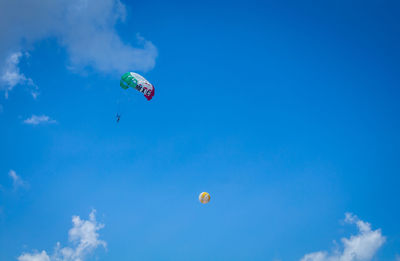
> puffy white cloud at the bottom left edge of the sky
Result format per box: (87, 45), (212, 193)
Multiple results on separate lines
(18, 210), (107, 261)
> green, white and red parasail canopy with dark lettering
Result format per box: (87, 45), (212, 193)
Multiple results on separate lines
(119, 72), (154, 101)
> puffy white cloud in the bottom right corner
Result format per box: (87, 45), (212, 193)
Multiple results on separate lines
(301, 213), (386, 261)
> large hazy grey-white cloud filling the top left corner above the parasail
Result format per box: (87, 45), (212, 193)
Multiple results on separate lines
(0, 0), (157, 96)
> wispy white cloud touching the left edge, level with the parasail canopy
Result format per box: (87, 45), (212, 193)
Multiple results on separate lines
(0, 52), (39, 99)
